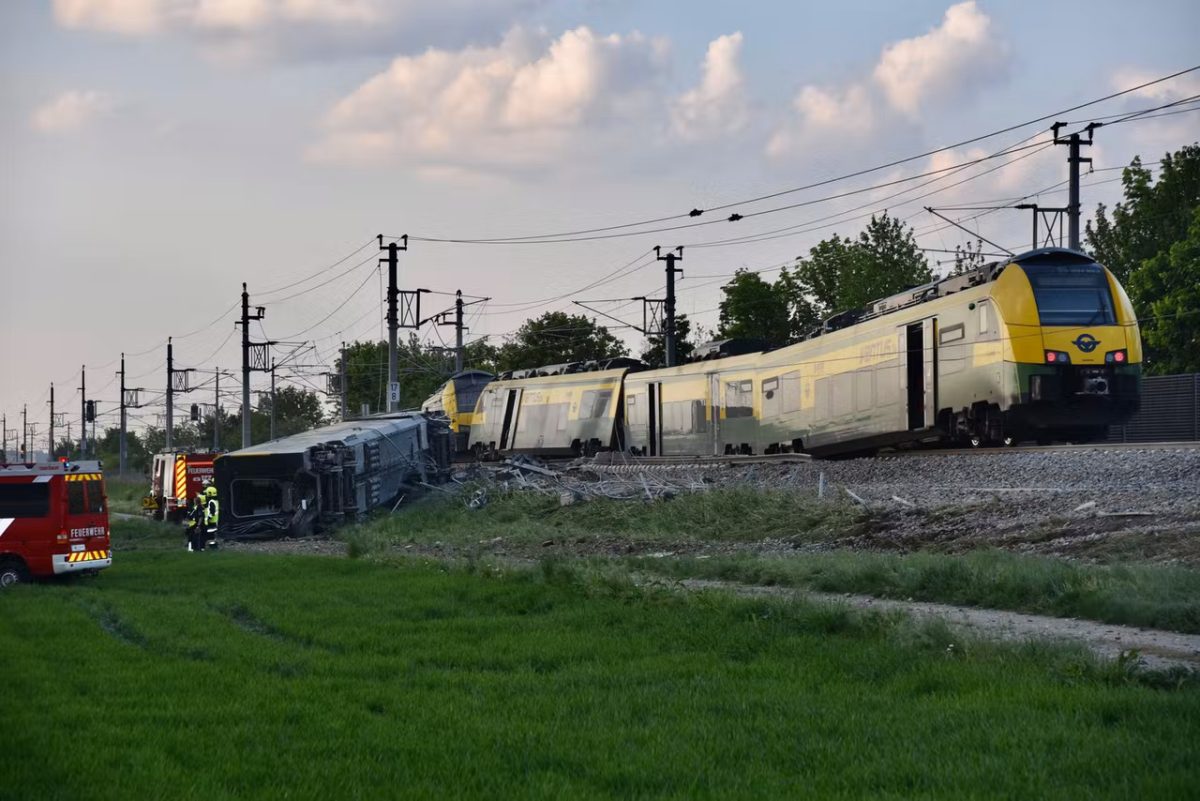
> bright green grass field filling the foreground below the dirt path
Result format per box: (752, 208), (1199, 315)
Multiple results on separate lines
(0, 546), (1200, 800)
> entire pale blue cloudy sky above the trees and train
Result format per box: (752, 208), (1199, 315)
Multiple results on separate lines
(0, 0), (1200, 439)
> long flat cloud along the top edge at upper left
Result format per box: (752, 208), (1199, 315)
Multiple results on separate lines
(54, 0), (545, 60)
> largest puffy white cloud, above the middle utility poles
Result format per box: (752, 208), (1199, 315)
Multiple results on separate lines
(308, 28), (667, 167)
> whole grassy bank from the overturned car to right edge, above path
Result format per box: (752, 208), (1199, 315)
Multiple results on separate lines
(338, 489), (1200, 633)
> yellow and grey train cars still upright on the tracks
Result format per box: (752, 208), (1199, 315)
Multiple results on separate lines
(444, 248), (1141, 456)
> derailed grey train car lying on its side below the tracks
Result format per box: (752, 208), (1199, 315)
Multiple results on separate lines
(215, 412), (452, 538)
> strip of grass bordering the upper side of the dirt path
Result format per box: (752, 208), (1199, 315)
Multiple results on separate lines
(632, 550), (1200, 633)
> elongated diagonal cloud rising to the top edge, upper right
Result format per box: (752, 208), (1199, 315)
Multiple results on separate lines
(767, 0), (1008, 158)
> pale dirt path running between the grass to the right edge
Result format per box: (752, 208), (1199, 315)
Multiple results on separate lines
(679, 579), (1200, 670)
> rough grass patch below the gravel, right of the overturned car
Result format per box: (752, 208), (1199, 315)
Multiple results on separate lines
(340, 488), (866, 549)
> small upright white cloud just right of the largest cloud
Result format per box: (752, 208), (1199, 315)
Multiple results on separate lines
(672, 32), (750, 139)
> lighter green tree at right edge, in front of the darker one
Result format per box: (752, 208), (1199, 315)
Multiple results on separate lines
(1129, 206), (1200, 373)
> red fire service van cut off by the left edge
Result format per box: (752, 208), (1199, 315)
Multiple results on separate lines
(0, 462), (113, 586)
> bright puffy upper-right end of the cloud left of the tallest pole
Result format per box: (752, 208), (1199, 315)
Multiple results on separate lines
(874, 0), (1006, 116)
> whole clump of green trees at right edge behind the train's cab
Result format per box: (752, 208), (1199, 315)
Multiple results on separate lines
(1087, 144), (1200, 373)
